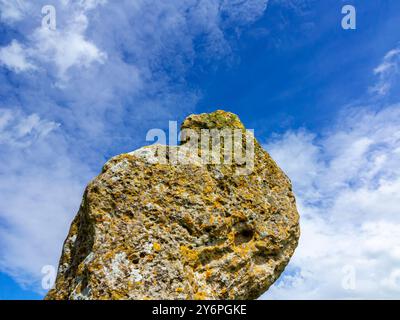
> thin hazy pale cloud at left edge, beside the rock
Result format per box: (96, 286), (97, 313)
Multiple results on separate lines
(0, 108), (90, 290)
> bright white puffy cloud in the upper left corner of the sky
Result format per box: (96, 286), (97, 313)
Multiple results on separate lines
(0, 1), (107, 81)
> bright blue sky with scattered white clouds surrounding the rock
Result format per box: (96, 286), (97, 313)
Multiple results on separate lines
(0, 0), (400, 299)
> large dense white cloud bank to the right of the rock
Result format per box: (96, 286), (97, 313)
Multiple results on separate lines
(264, 105), (400, 299)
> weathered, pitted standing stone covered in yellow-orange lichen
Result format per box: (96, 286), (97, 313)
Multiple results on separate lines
(46, 111), (300, 299)
